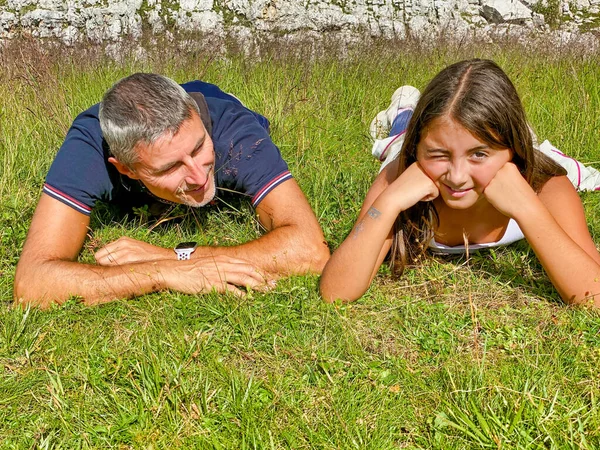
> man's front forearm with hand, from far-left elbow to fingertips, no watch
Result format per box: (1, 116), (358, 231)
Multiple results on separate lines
(15, 255), (267, 307)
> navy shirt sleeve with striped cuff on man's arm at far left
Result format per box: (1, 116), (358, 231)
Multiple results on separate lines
(43, 105), (113, 215)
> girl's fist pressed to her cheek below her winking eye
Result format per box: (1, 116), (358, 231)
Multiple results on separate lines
(382, 162), (440, 211)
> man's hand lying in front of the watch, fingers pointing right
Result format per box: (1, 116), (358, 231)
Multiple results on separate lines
(163, 255), (275, 296)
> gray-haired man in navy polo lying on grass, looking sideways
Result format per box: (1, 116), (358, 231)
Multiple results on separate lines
(14, 74), (329, 307)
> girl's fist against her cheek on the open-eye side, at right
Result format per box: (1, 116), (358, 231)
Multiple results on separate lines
(483, 162), (537, 219)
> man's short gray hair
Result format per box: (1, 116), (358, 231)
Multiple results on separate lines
(99, 73), (199, 168)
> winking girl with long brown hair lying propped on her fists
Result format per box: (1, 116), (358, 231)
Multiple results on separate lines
(320, 59), (600, 306)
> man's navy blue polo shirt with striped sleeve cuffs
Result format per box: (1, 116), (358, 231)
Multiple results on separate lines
(43, 81), (292, 215)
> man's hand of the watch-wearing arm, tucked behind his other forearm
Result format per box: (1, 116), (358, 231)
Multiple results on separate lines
(94, 236), (177, 266)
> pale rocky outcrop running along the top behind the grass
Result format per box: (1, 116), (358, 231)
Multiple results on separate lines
(0, 0), (600, 42)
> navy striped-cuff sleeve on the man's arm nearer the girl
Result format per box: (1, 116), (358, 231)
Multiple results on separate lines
(207, 99), (292, 207)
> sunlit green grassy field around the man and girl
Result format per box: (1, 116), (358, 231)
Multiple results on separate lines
(0, 34), (600, 449)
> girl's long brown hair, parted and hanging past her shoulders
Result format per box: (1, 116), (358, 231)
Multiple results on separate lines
(391, 59), (566, 274)
